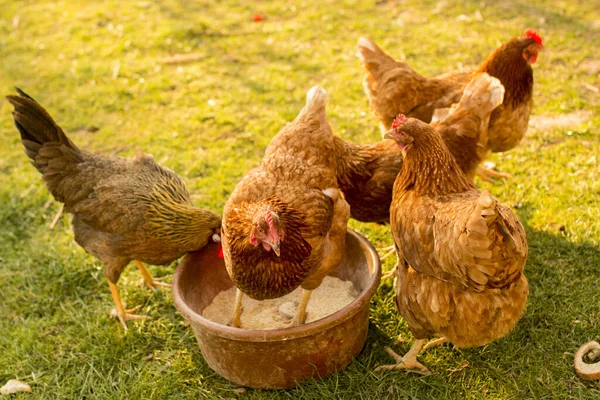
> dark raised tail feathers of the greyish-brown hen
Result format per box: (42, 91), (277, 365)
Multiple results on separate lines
(6, 88), (77, 160)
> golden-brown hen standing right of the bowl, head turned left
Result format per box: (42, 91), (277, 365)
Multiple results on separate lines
(379, 116), (528, 370)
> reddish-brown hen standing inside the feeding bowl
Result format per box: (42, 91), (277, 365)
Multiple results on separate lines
(222, 87), (350, 327)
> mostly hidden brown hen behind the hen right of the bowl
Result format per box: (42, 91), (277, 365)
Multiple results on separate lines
(334, 73), (504, 223)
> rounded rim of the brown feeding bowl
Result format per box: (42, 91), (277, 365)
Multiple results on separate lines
(172, 228), (381, 342)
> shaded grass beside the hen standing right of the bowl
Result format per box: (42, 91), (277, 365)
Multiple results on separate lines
(358, 204), (600, 398)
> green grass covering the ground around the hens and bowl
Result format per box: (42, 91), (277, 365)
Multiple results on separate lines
(0, 0), (600, 399)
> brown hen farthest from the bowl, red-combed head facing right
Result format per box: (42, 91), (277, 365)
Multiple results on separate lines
(358, 30), (544, 179)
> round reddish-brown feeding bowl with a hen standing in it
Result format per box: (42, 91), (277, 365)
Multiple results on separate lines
(173, 229), (381, 389)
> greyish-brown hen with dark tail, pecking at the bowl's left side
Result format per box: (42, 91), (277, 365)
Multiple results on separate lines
(7, 89), (221, 329)
